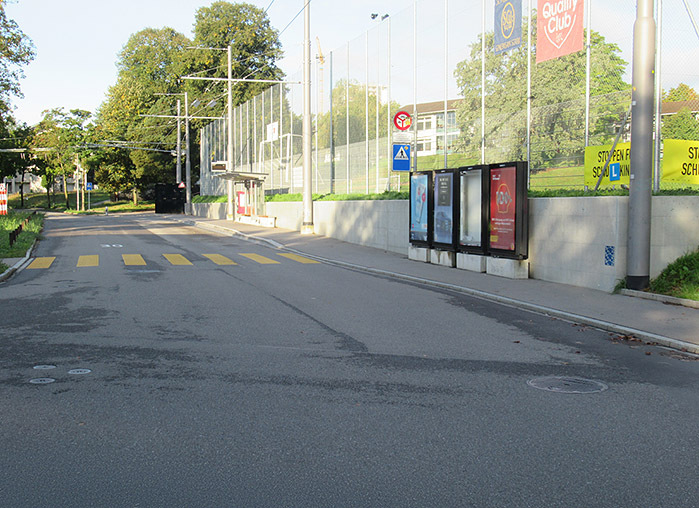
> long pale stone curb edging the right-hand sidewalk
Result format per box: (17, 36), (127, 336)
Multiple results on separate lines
(175, 219), (699, 354)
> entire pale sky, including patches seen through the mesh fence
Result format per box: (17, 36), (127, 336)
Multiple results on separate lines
(5, 0), (699, 125)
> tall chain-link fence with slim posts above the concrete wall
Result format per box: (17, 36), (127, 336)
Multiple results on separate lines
(201, 0), (699, 194)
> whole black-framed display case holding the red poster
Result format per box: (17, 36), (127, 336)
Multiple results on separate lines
(485, 162), (529, 260)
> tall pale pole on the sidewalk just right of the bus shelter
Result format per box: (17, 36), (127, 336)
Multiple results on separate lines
(301, 0), (314, 235)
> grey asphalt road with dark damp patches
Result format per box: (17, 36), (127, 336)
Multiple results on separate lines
(0, 214), (699, 507)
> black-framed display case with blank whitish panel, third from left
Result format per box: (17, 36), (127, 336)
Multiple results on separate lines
(457, 165), (490, 255)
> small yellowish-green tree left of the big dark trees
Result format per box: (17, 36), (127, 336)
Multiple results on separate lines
(32, 108), (92, 208)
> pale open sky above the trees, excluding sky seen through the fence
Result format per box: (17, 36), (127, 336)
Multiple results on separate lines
(5, 0), (413, 125)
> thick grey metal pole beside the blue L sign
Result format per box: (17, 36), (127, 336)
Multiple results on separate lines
(626, 0), (659, 290)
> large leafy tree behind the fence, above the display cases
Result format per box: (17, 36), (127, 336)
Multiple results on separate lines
(454, 19), (630, 169)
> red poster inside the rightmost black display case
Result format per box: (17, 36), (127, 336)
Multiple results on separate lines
(490, 167), (517, 251)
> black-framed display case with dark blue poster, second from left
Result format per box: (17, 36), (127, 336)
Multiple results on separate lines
(432, 169), (459, 250)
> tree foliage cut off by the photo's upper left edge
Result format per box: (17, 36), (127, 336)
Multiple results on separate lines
(0, 2), (35, 121)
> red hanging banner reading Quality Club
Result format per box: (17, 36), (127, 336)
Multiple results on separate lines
(536, 0), (585, 63)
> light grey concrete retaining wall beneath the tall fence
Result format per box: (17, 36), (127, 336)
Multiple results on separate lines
(195, 196), (699, 291)
